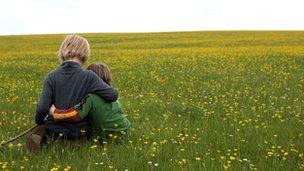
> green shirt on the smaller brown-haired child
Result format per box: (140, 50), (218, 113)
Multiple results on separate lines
(78, 94), (131, 133)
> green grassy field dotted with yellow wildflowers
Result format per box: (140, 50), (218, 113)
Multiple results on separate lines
(0, 32), (304, 170)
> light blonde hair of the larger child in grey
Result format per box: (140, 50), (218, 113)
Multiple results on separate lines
(58, 35), (91, 63)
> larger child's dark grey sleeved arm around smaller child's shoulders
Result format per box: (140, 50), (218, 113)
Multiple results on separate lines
(89, 71), (118, 102)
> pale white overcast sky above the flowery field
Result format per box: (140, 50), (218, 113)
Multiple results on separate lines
(0, 0), (304, 35)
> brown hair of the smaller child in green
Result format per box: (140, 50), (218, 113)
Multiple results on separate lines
(87, 63), (112, 85)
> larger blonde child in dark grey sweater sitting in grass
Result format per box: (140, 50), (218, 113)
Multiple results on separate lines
(26, 35), (118, 152)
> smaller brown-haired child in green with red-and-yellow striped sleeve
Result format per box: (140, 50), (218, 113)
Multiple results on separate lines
(50, 63), (131, 142)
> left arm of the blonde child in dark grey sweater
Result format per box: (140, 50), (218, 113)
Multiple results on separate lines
(35, 75), (52, 124)
